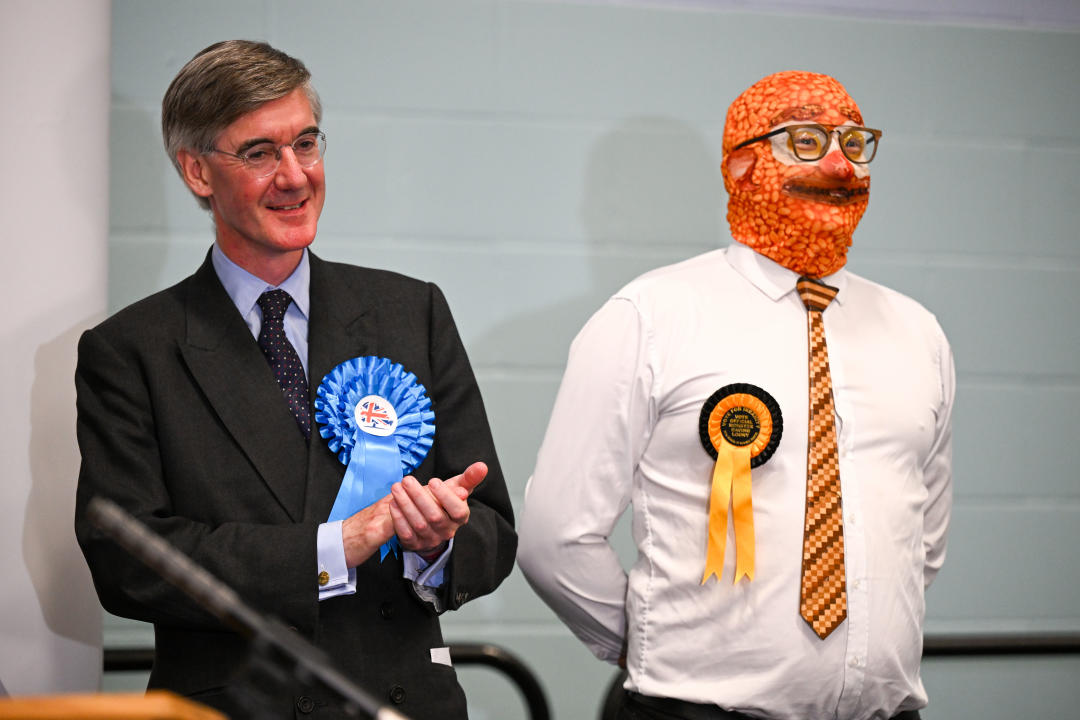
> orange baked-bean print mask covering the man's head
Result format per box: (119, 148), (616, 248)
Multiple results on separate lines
(721, 71), (870, 277)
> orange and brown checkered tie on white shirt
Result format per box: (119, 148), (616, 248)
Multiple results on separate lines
(796, 277), (848, 639)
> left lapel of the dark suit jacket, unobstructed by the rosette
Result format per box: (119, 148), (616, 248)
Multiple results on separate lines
(180, 254), (318, 520)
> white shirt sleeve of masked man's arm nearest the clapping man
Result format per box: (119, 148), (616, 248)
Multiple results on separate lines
(517, 298), (653, 662)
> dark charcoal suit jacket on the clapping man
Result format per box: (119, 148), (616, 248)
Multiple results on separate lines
(76, 250), (516, 720)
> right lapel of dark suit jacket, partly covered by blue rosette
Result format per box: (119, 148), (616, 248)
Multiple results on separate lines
(303, 252), (378, 522)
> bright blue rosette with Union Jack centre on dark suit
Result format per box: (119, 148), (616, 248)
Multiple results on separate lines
(315, 355), (435, 559)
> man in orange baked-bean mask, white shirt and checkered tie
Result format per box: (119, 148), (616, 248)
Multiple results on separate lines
(518, 72), (955, 720)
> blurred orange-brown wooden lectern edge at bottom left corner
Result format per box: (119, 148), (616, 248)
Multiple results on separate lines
(0, 690), (227, 720)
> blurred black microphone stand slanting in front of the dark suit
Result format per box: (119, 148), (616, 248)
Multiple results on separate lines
(87, 498), (408, 720)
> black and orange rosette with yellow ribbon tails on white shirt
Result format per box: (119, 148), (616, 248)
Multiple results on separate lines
(699, 382), (784, 585)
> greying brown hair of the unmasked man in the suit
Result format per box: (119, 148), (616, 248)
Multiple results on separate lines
(161, 40), (323, 209)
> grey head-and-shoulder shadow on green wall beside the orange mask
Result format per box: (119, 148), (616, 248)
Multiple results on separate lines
(470, 117), (726, 375)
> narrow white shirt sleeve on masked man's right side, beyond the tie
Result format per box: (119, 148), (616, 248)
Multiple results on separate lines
(922, 328), (956, 587)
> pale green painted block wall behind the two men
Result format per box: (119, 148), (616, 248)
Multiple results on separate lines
(107, 0), (1080, 720)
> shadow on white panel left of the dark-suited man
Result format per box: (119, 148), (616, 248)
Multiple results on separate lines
(23, 313), (102, 649)
